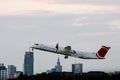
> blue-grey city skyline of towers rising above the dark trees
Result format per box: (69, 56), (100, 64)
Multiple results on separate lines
(0, 57), (83, 74)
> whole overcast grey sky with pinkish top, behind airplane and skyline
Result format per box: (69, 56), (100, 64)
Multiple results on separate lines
(0, 0), (120, 73)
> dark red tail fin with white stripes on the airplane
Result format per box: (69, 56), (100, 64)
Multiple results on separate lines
(96, 46), (111, 59)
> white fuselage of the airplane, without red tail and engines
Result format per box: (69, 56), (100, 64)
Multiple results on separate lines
(31, 44), (99, 59)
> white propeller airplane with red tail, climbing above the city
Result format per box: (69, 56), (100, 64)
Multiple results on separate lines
(30, 43), (111, 59)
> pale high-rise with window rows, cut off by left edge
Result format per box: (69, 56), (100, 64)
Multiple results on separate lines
(0, 63), (7, 80)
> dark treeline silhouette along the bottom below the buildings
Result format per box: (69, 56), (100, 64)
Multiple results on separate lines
(8, 72), (120, 80)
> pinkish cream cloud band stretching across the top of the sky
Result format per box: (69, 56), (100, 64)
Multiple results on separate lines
(0, 0), (120, 15)
